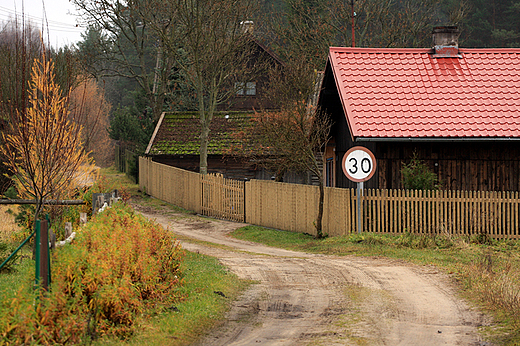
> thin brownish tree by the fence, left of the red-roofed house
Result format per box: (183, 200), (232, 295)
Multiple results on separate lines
(229, 57), (331, 238)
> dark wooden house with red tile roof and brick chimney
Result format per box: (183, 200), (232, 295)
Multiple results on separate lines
(319, 27), (520, 191)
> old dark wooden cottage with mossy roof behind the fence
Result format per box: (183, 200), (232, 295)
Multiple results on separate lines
(145, 29), (283, 180)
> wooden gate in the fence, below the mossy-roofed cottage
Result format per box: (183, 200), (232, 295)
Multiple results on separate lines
(201, 174), (245, 222)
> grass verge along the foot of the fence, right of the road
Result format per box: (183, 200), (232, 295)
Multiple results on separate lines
(232, 226), (520, 345)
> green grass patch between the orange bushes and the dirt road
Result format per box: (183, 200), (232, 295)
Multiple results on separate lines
(94, 252), (250, 346)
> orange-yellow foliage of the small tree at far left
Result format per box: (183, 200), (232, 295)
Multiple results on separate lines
(0, 58), (92, 203)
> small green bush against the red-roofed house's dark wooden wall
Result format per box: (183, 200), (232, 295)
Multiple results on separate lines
(401, 153), (440, 190)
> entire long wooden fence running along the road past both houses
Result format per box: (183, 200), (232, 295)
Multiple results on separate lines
(139, 158), (520, 239)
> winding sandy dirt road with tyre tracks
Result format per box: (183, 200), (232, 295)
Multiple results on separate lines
(136, 206), (490, 346)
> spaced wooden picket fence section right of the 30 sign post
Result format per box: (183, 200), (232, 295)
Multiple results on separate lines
(362, 190), (520, 238)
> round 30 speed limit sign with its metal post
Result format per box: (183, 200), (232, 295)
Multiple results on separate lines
(342, 147), (376, 233)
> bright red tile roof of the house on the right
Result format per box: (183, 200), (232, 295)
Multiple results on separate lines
(329, 48), (520, 139)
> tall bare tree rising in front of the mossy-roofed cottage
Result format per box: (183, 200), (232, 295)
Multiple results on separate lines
(155, 0), (255, 174)
